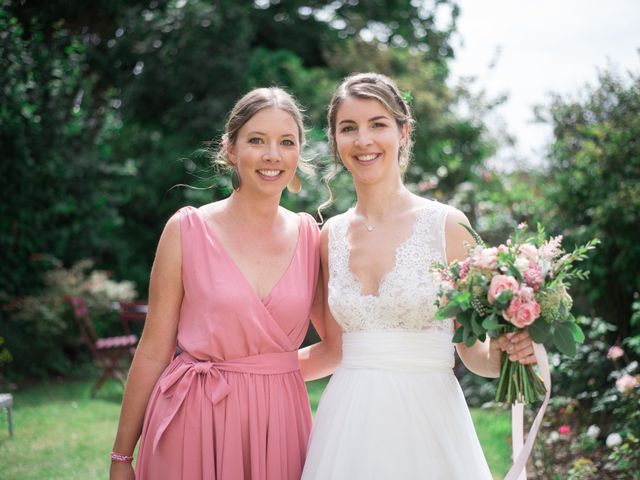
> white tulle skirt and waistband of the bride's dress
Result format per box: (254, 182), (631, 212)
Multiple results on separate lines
(302, 330), (492, 480)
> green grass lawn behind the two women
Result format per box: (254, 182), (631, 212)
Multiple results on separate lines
(0, 380), (510, 480)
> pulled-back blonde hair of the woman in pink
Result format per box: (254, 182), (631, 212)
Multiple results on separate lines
(209, 87), (313, 173)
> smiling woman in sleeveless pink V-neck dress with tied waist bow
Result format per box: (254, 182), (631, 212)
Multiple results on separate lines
(110, 88), (321, 480)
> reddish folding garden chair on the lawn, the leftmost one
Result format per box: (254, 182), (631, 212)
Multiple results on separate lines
(65, 295), (138, 397)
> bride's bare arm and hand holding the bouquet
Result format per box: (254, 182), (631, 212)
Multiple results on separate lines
(445, 209), (536, 378)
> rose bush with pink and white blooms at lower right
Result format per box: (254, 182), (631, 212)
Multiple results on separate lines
(534, 314), (640, 480)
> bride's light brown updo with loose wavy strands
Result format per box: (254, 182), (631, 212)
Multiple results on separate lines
(318, 72), (414, 216)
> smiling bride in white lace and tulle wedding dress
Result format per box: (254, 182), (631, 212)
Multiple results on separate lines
(300, 73), (535, 480)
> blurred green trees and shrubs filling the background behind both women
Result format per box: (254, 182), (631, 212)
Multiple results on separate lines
(0, 0), (640, 478)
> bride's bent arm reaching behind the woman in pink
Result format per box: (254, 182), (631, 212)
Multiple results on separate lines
(298, 221), (342, 381)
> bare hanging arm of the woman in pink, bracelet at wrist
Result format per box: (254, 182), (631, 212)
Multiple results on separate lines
(110, 214), (183, 480)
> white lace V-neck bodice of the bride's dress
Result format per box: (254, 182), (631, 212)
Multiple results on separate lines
(328, 201), (453, 332)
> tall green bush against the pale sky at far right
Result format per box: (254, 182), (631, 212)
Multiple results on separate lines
(547, 67), (640, 337)
